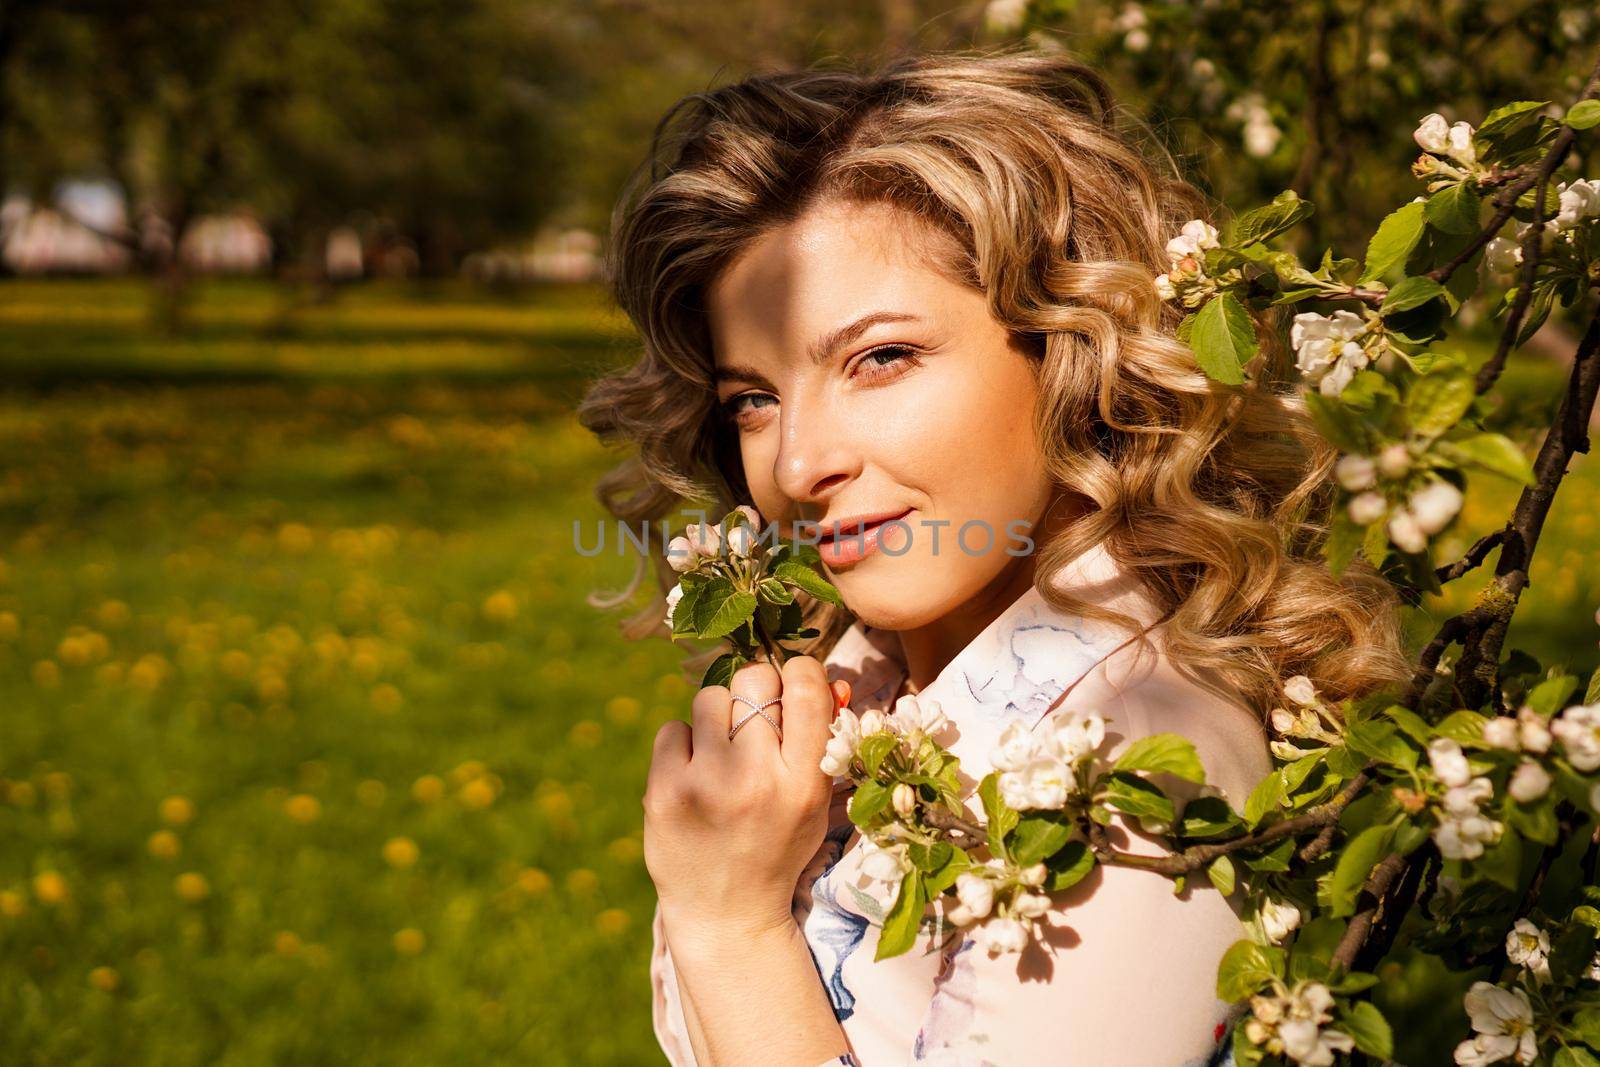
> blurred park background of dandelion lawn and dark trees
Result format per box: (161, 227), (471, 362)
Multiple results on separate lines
(0, 0), (1600, 1065)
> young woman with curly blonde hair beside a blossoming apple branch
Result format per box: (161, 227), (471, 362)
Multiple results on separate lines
(581, 50), (1405, 1067)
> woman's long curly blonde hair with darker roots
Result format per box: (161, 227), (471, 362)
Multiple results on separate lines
(579, 46), (1408, 715)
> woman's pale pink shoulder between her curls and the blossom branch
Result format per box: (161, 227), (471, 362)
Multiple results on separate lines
(1058, 627), (1274, 809)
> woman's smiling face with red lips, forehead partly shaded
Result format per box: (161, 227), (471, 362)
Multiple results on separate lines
(707, 202), (1053, 630)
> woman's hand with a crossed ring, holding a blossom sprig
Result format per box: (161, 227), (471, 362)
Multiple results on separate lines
(645, 656), (850, 949)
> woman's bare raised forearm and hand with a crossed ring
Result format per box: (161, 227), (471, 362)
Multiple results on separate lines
(645, 656), (850, 1067)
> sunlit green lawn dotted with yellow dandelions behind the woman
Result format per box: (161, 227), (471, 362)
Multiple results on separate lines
(0, 280), (1600, 1067)
